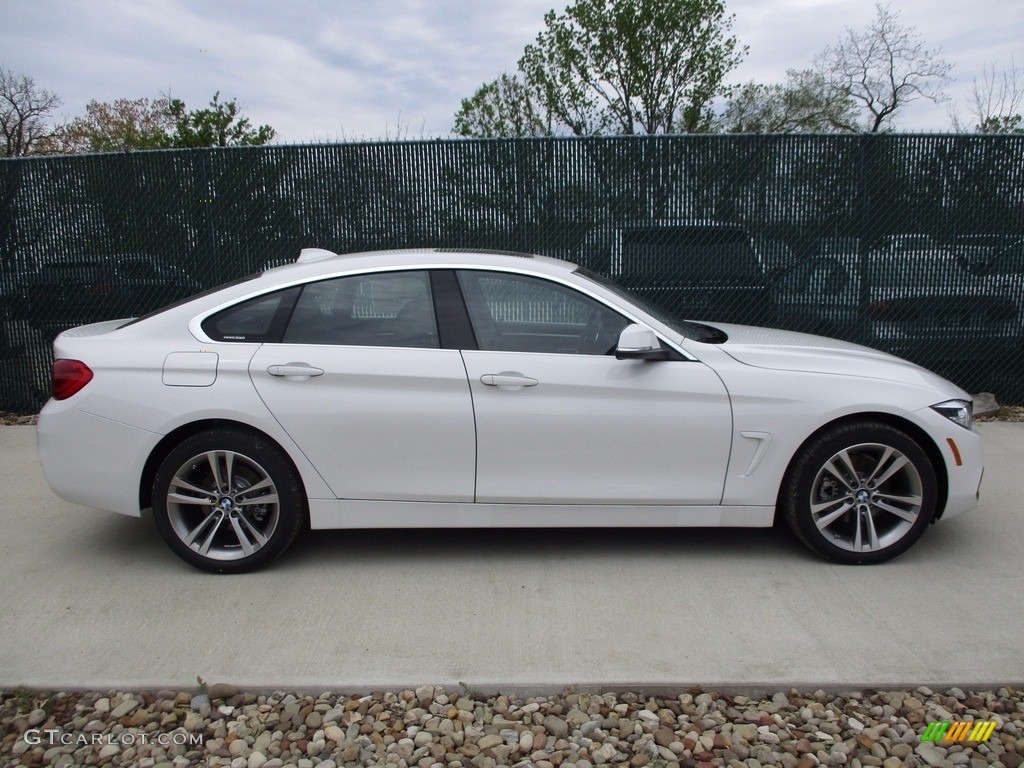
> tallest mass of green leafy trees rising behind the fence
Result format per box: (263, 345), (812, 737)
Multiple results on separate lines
(456, 0), (745, 136)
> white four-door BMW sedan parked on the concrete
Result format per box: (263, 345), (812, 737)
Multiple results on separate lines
(39, 249), (982, 572)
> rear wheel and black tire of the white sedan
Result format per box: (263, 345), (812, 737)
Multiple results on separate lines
(153, 428), (309, 573)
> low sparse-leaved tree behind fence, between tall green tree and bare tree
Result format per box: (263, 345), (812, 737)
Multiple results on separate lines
(715, 70), (858, 133)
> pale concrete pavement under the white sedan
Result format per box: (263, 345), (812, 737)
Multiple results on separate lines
(0, 423), (1024, 692)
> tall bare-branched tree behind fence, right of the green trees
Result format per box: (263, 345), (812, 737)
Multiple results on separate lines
(817, 4), (952, 133)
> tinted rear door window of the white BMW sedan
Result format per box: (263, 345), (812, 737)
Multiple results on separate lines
(285, 271), (438, 348)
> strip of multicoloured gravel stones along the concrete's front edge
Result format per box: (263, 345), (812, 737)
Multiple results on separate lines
(0, 685), (1024, 768)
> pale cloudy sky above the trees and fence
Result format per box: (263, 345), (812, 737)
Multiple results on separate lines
(0, 0), (1024, 143)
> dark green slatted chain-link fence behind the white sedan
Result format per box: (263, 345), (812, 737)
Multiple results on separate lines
(0, 135), (1024, 411)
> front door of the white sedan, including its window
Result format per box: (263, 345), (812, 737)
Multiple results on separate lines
(460, 270), (732, 505)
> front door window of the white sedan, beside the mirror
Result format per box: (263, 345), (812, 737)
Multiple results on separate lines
(459, 271), (629, 354)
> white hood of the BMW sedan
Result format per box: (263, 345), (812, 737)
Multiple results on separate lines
(715, 324), (967, 395)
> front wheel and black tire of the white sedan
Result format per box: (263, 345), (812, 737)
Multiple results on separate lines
(779, 422), (938, 565)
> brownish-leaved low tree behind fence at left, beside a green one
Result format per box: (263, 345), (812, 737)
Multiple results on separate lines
(46, 98), (174, 153)
